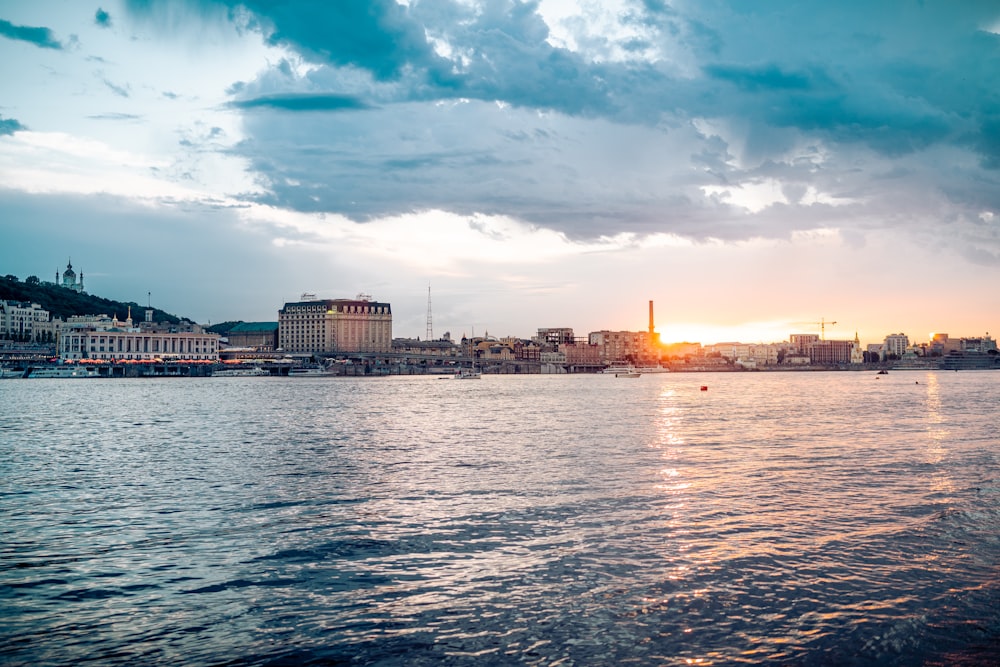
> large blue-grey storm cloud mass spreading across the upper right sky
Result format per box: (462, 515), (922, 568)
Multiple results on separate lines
(133, 0), (1000, 253)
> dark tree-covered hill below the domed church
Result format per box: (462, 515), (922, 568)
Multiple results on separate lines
(0, 275), (181, 324)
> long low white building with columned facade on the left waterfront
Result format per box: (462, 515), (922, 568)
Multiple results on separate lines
(58, 316), (219, 361)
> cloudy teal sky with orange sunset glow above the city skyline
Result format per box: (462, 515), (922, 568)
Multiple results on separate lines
(0, 0), (1000, 344)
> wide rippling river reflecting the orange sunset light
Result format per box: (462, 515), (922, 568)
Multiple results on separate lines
(0, 371), (1000, 666)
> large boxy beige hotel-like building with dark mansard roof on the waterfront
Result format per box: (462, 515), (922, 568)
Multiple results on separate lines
(278, 294), (392, 353)
